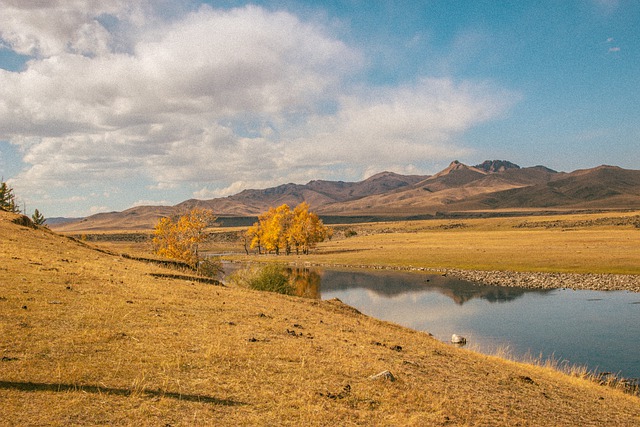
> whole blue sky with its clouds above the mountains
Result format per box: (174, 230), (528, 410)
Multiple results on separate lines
(0, 0), (640, 217)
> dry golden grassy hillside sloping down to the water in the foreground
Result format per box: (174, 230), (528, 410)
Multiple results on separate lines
(0, 213), (640, 426)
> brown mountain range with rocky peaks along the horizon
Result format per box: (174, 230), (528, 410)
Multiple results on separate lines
(49, 160), (640, 232)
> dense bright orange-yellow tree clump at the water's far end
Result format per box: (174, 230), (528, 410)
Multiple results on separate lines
(246, 202), (331, 255)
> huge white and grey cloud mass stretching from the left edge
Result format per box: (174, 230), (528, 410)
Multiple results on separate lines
(0, 0), (517, 211)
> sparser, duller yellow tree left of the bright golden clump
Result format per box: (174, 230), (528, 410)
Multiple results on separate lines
(153, 208), (216, 268)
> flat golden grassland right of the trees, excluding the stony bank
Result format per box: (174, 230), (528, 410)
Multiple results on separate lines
(228, 212), (640, 274)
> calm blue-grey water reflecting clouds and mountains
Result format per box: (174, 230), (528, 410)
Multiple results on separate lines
(221, 269), (640, 379)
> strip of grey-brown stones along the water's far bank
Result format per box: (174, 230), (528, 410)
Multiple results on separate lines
(290, 263), (640, 292)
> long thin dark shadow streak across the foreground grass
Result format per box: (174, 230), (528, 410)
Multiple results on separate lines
(0, 381), (246, 406)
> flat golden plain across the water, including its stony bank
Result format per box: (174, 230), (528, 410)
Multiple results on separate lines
(63, 211), (640, 292)
